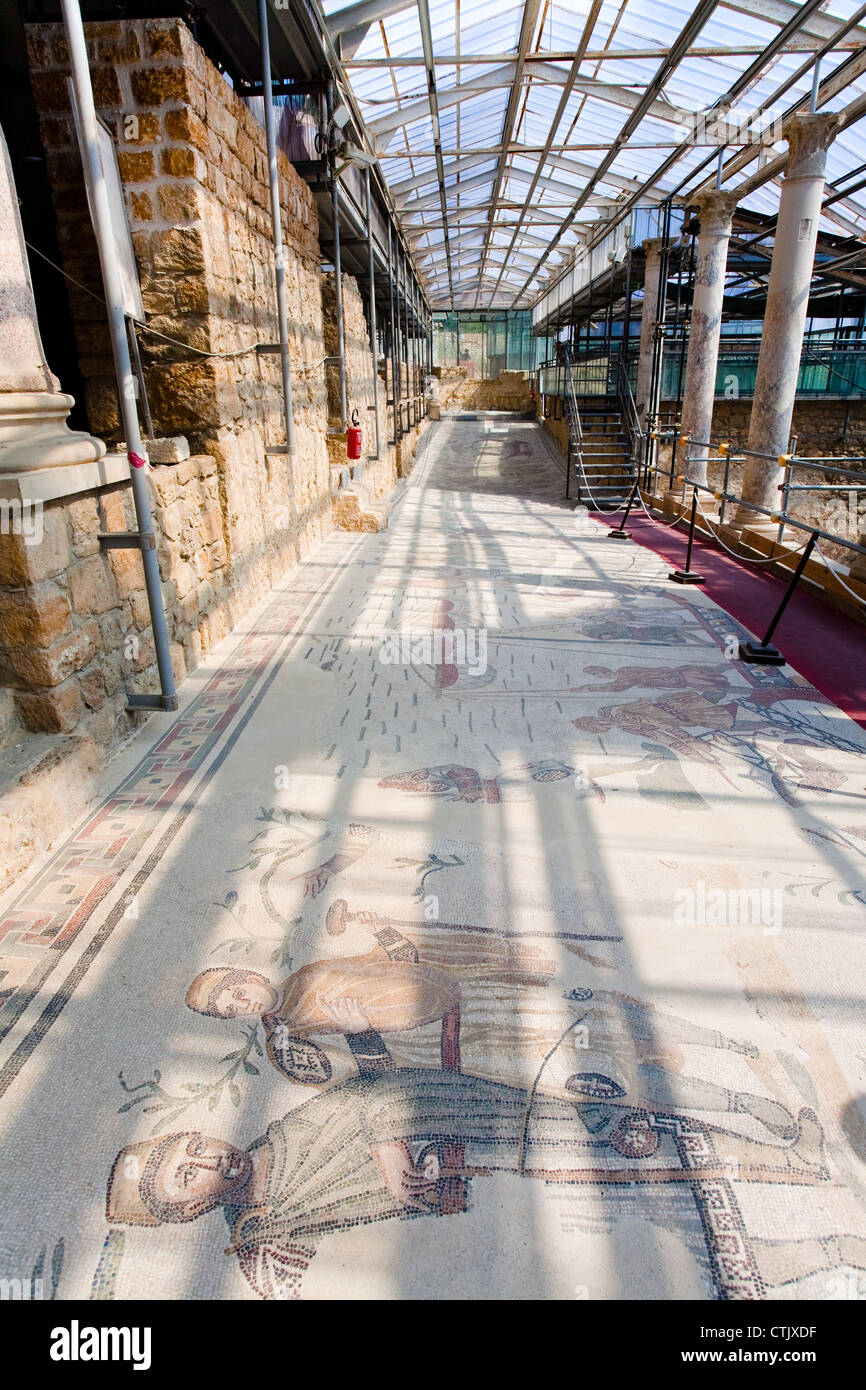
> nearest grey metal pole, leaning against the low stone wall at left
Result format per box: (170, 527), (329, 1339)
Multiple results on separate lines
(63, 0), (178, 709)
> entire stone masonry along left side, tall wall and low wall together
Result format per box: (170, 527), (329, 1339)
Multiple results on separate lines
(0, 19), (420, 887)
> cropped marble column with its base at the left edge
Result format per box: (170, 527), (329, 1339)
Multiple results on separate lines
(0, 120), (106, 475)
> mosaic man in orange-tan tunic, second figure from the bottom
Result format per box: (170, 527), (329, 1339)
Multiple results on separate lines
(186, 904), (796, 1143)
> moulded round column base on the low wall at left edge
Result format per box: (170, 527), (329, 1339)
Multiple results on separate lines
(0, 391), (106, 475)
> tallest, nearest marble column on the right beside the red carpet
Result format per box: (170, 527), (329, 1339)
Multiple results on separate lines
(731, 113), (840, 530)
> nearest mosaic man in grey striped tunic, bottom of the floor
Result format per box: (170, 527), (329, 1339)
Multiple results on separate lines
(107, 1069), (828, 1298)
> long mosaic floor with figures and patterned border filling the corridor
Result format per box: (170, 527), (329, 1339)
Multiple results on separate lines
(0, 416), (866, 1300)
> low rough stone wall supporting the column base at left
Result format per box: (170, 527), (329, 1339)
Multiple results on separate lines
(0, 456), (223, 745)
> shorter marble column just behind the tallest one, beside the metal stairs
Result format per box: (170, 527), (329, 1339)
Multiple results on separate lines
(681, 189), (737, 482)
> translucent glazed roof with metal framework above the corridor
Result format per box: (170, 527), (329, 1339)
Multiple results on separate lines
(328, 0), (866, 309)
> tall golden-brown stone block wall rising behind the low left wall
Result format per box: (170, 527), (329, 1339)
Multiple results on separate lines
(28, 19), (331, 602)
